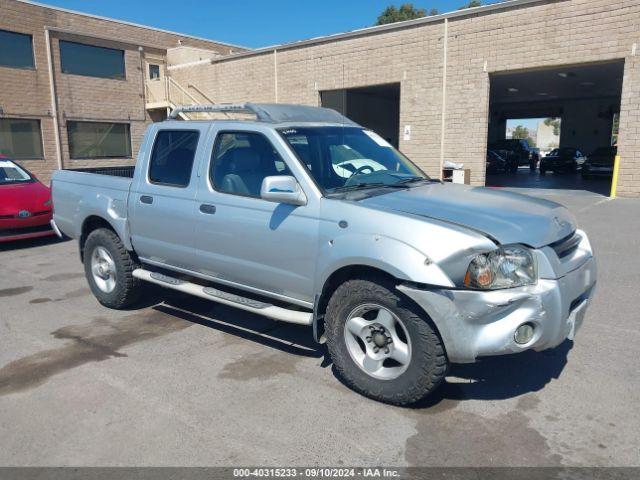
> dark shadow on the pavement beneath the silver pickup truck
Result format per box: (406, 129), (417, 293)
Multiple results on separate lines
(153, 292), (573, 408)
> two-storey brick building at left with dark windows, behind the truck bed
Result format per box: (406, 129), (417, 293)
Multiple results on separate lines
(0, 0), (241, 182)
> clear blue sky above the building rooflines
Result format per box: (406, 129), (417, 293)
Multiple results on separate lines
(41, 0), (492, 47)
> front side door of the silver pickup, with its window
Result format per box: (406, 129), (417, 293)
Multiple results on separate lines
(195, 124), (320, 305)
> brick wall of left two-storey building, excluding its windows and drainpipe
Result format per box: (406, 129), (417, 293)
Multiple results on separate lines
(0, 0), (238, 182)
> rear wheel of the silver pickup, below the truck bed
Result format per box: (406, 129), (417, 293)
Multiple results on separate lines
(84, 228), (141, 309)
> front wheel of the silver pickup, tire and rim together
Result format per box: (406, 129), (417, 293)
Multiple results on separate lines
(325, 279), (448, 405)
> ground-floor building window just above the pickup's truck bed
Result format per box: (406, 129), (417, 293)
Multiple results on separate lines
(67, 121), (131, 159)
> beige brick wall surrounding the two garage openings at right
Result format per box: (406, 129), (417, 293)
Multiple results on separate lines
(171, 0), (640, 196)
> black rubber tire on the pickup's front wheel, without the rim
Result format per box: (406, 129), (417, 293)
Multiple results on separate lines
(325, 278), (449, 406)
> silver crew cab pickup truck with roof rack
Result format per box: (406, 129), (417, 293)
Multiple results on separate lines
(53, 103), (596, 405)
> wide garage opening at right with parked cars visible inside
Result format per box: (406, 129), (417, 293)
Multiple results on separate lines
(486, 61), (624, 195)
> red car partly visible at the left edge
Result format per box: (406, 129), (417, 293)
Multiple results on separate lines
(0, 155), (55, 243)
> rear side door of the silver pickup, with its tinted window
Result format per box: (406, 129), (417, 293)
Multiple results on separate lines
(129, 122), (208, 269)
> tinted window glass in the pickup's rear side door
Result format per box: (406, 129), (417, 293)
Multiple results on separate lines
(149, 130), (200, 187)
